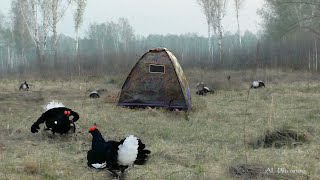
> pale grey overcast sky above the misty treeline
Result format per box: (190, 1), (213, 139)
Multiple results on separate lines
(0, 0), (263, 36)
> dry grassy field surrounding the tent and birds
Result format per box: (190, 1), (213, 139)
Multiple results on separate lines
(0, 70), (320, 180)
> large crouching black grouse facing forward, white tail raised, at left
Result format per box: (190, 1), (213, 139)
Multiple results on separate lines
(31, 101), (79, 134)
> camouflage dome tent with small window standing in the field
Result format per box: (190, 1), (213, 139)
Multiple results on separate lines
(118, 48), (191, 110)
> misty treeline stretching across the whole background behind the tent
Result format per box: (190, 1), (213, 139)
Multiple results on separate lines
(0, 0), (319, 76)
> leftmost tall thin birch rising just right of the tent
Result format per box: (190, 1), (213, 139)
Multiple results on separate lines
(197, 0), (213, 63)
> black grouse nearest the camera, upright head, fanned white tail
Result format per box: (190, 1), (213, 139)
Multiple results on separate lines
(87, 125), (150, 177)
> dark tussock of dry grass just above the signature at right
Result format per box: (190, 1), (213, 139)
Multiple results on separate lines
(249, 129), (310, 148)
